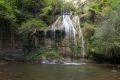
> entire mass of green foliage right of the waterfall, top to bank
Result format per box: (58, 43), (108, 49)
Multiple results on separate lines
(81, 0), (120, 63)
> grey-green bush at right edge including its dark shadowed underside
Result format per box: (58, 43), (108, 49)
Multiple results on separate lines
(93, 2), (120, 63)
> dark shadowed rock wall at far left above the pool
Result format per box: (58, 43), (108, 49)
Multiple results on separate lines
(0, 26), (23, 60)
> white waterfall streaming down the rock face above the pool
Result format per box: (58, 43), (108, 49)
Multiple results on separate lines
(50, 15), (85, 65)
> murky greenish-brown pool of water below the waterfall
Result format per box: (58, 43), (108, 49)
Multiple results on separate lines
(0, 63), (120, 80)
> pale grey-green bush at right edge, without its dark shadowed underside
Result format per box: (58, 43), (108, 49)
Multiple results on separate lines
(95, 1), (120, 52)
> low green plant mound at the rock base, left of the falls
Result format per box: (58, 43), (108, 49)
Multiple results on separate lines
(26, 48), (59, 60)
